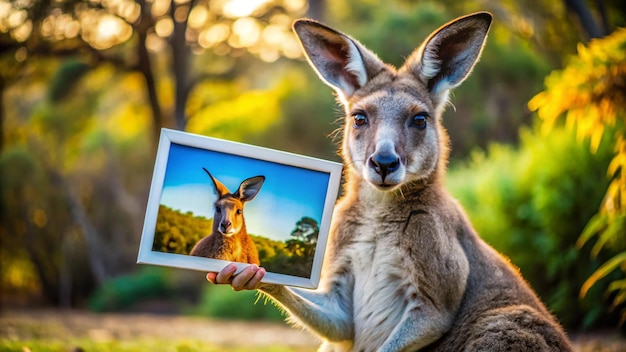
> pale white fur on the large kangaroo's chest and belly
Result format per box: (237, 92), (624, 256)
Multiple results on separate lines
(347, 217), (419, 351)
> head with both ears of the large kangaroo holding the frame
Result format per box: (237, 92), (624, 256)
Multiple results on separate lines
(294, 12), (492, 191)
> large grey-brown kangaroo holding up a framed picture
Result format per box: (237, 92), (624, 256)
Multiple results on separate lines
(207, 12), (572, 352)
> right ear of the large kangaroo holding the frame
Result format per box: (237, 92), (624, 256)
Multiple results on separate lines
(405, 12), (492, 97)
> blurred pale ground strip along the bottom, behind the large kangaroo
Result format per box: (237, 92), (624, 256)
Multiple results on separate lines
(0, 309), (626, 352)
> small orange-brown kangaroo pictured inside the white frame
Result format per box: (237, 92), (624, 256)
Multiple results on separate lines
(190, 168), (265, 265)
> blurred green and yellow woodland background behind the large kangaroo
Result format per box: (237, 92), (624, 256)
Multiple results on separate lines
(0, 0), (626, 350)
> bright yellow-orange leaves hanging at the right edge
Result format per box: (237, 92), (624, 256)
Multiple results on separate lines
(528, 28), (626, 323)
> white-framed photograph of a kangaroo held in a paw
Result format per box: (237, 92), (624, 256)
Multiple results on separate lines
(137, 129), (342, 288)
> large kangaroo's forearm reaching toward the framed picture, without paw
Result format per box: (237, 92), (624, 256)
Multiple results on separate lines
(259, 280), (354, 341)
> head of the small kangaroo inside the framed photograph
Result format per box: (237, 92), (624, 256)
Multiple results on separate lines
(202, 168), (265, 237)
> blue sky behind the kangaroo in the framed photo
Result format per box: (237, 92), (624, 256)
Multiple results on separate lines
(160, 143), (329, 241)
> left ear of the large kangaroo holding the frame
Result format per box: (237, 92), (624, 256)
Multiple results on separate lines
(293, 20), (385, 102)
